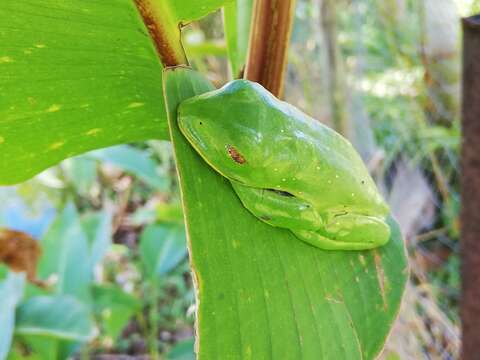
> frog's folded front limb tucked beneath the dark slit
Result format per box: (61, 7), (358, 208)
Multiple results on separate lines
(232, 181), (322, 231)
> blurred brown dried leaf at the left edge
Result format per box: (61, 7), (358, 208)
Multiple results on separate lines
(0, 229), (46, 287)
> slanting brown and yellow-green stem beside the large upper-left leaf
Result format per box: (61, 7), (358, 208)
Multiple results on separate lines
(134, 0), (188, 66)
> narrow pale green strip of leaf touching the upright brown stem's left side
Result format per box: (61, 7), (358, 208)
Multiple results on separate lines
(223, 0), (253, 78)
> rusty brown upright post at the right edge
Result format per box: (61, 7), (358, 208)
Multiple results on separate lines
(460, 15), (480, 360)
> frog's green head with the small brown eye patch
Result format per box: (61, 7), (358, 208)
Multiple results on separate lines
(178, 80), (278, 186)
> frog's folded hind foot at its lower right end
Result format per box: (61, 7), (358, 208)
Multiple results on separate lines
(292, 214), (390, 250)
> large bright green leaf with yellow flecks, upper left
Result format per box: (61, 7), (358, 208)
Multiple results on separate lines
(0, 0), (167, 184)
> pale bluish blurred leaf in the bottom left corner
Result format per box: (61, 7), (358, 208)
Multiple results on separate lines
(0, 272), (25, 360)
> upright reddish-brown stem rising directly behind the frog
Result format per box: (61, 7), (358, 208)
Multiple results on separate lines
(245, 0), (295, 97)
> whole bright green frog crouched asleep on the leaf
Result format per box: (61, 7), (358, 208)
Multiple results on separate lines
(178, 80), (390, 250)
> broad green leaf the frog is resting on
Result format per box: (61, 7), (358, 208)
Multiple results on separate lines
(164, 68), (408, 360)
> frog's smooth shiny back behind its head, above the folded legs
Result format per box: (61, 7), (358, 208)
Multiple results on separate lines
(267, 90), (388, 214)
